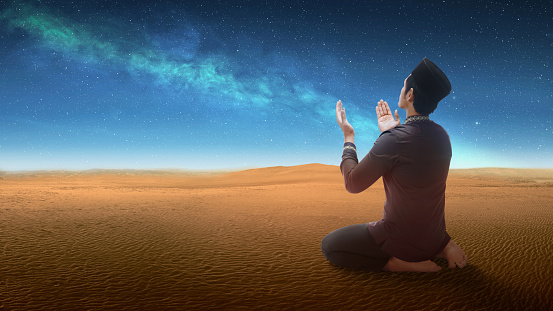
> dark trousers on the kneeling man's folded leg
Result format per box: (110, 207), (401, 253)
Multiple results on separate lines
(321, 224), (391, 271)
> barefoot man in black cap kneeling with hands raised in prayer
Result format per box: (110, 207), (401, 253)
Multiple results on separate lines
(321, 58), (467, 272)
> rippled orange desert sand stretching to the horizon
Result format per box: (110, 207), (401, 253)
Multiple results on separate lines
(0, 164), (553, 310)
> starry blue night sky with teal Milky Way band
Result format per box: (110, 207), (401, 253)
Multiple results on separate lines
(0, 0), (553, 171)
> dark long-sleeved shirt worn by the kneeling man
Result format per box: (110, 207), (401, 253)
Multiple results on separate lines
(340, 120), (451, 262)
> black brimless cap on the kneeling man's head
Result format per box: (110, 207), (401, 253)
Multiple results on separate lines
(411, 57), (451, 103)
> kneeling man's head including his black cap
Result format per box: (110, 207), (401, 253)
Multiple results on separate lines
(398, 57), (451, 115)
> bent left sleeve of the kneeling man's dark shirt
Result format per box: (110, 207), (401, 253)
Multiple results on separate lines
(340, 131), (398, 193)
